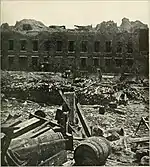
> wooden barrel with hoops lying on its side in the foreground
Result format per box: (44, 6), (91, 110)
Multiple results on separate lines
(74, 137), (111, 166)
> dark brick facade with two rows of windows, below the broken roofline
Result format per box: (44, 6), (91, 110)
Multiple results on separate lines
(1, 31), (148, 73)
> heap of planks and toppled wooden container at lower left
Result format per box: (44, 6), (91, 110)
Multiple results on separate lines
(1, 111), (68, 166)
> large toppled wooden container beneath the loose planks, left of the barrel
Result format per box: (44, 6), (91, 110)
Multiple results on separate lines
(5, 129), (67, 166)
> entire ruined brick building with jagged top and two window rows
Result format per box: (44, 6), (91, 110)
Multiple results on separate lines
(0, 18), (149, 75)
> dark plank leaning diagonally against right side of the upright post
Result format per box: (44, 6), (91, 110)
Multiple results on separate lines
(76, 103), (91, 137)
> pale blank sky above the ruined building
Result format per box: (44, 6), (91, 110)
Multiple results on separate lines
(1, 0), (150, 28)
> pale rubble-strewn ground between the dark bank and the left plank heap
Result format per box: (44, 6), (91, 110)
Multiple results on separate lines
(1, 98), (59, 123)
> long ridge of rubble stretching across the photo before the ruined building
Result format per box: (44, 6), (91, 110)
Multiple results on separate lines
(1, 72), (149, 105)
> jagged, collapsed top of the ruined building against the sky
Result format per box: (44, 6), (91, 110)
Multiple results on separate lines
(0, 18), (148, 36)
